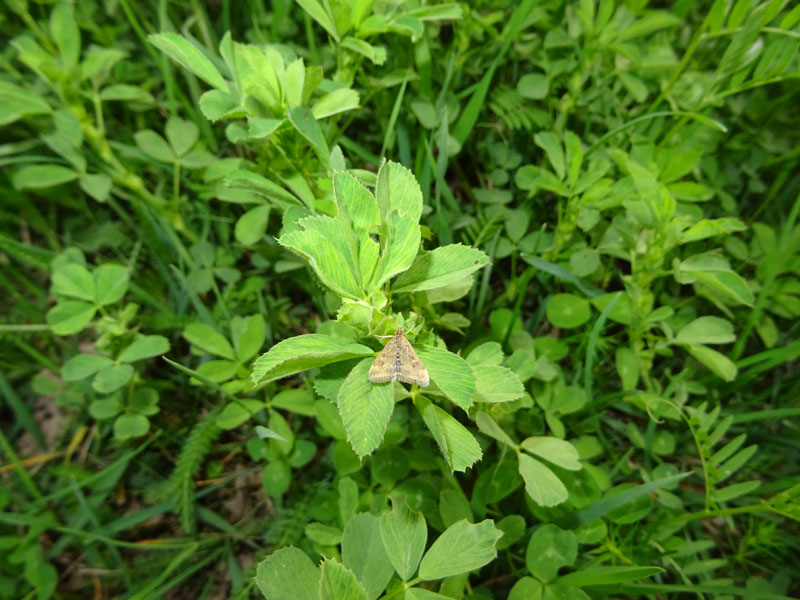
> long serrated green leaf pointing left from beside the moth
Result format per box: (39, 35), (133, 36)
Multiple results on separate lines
(251, 334), (374, 383)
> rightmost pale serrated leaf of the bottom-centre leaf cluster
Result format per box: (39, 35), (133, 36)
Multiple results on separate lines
(419, 519), (503, 581)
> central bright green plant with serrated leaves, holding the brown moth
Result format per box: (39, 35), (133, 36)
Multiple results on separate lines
(252, 161), (489, 464)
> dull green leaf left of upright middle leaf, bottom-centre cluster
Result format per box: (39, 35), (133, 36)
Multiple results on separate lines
(342, 513), (394, 600)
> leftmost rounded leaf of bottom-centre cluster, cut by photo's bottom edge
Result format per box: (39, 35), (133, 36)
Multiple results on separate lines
(255, 546), (321, 600)
